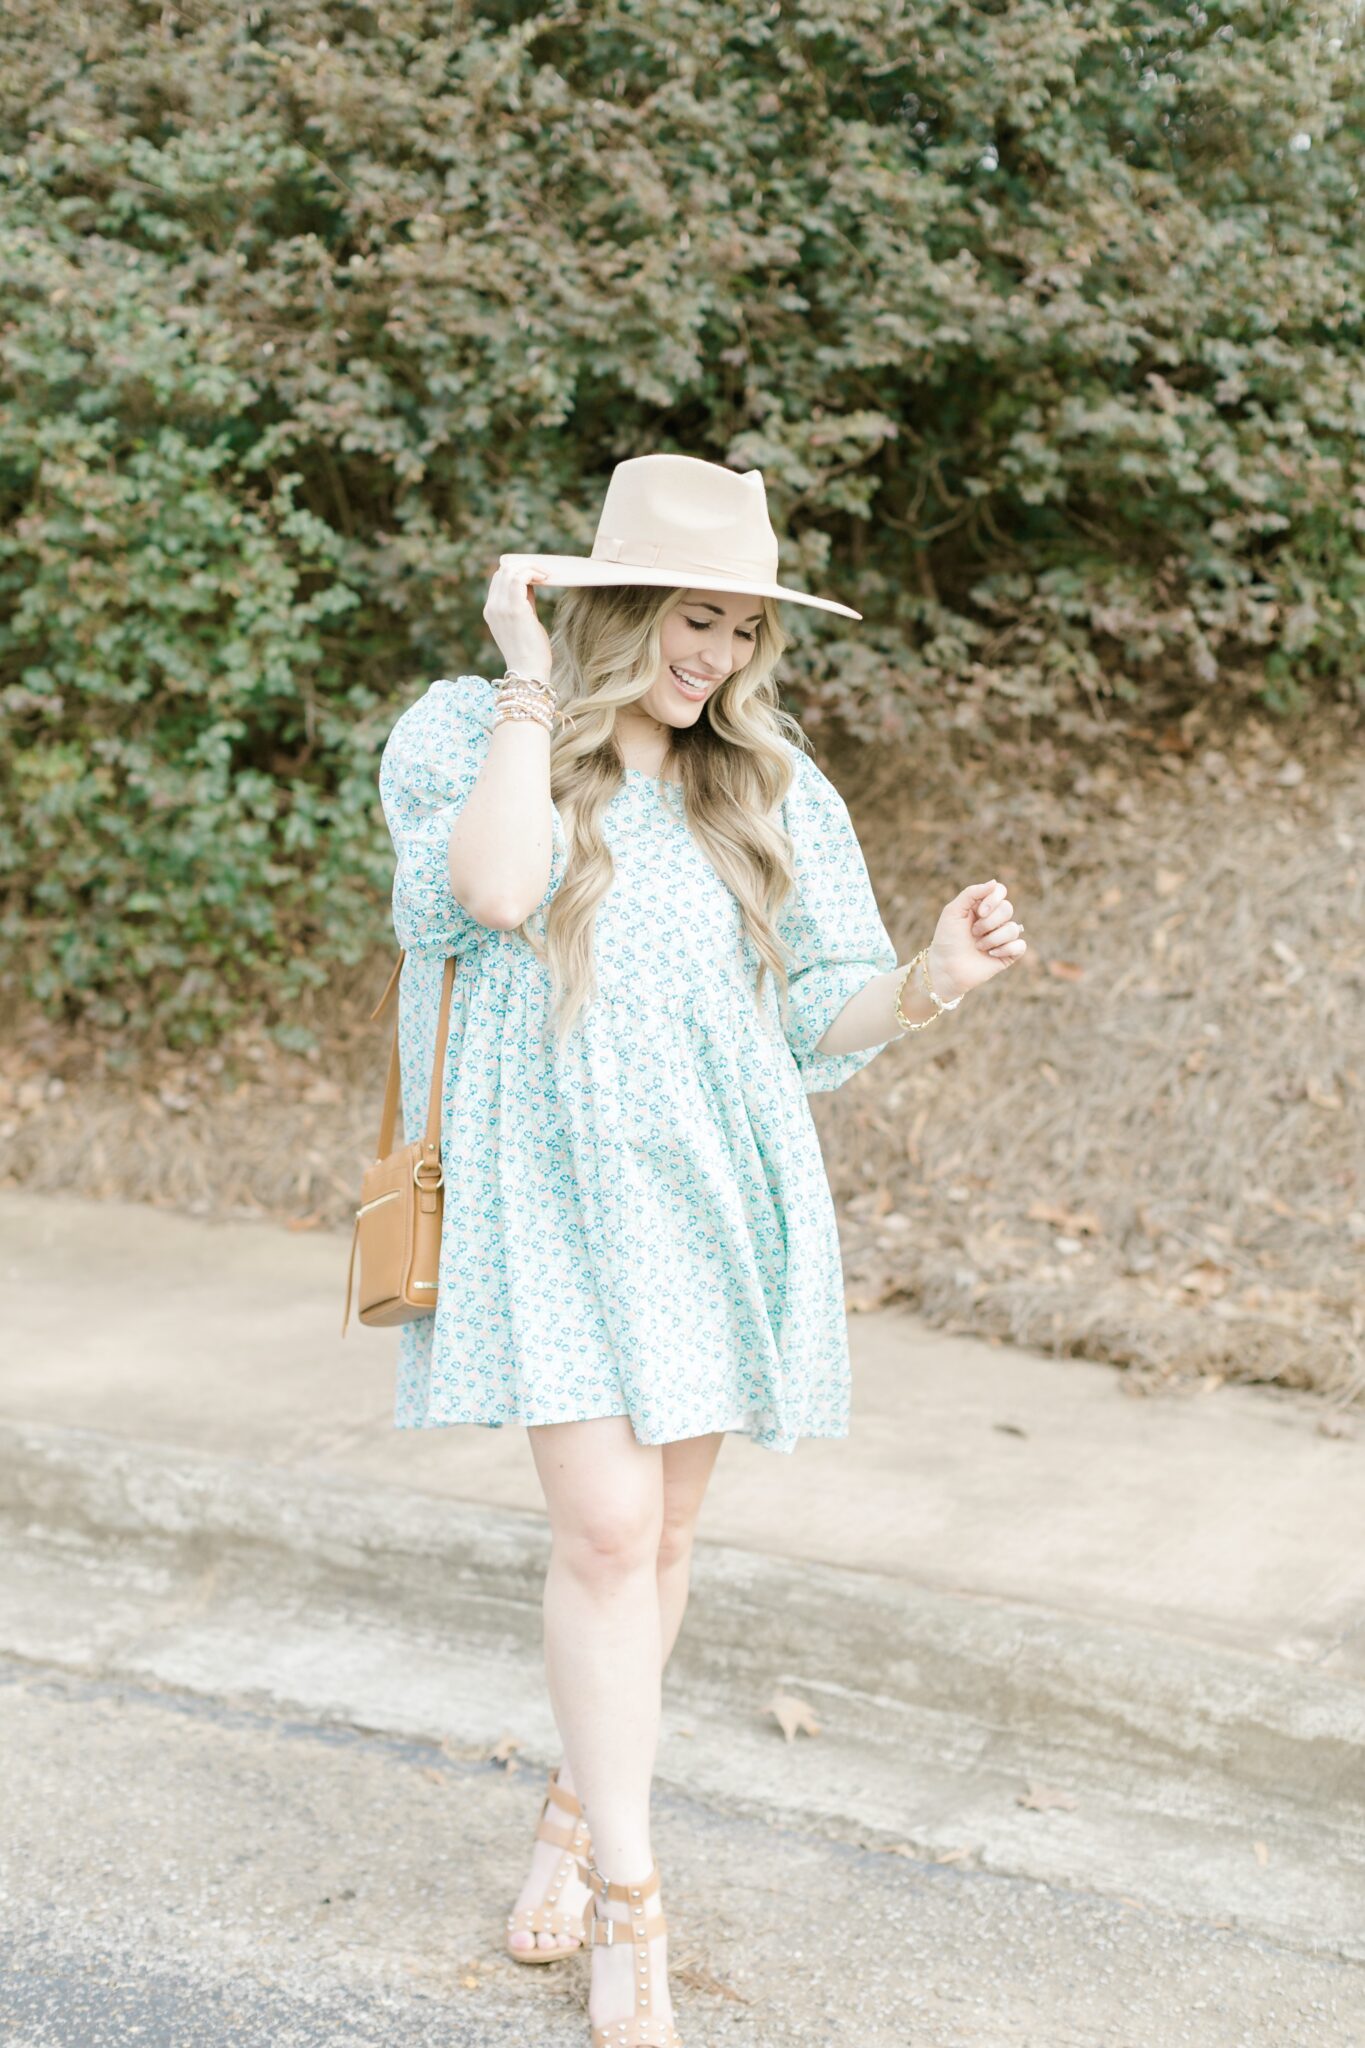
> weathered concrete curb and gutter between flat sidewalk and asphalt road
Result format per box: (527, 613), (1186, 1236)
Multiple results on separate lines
(0, 1425), (1365, 1960)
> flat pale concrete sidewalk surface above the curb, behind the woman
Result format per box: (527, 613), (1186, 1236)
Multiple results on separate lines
(0, 1192), (1365, 1681)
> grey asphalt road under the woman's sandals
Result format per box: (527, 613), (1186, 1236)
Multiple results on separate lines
(0, 1661), (1365, 2048)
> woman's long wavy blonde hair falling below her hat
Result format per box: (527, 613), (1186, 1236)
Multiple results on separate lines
(516, 584), (806, 1042)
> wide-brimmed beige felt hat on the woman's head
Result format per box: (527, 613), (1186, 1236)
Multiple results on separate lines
(501, 455), (862, 618)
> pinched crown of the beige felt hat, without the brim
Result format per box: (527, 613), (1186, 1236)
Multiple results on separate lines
(591, 455), (778, 588)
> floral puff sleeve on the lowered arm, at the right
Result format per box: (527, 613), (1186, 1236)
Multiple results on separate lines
(778, 748), (900, 1094)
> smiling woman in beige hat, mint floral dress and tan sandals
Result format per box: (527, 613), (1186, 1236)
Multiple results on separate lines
(381, 455), (1025, 2048)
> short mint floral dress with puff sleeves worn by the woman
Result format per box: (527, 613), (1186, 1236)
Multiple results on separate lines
(379, 676), (898, 1452)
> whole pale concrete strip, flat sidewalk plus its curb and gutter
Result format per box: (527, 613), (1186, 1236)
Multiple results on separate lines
(0, 1194), (1365, 1960)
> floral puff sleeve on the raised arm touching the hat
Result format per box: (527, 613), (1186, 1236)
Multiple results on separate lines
(379, 676), (569, 958)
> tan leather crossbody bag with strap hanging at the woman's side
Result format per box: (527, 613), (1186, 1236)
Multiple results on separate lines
(342, 952), (458, 1335)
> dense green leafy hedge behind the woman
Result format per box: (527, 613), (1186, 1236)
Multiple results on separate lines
(0, 0), (1365, 1042)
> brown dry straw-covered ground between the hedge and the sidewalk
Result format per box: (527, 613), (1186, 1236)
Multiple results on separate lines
(0, 700), (1365, 1407)
